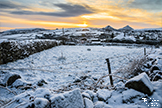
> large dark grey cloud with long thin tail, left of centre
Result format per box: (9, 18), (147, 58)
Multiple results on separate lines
(11, 3), (95, 17)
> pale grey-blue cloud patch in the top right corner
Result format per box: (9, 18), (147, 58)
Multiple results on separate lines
(128, 0), (162, 11)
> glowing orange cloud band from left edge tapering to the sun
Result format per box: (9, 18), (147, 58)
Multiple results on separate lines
(0, 16), (88, 31)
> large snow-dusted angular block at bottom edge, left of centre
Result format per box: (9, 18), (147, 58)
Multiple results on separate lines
(50, 89), (84, 108)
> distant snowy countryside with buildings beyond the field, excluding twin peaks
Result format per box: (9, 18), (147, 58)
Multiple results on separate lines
(0, 28), (162, 44)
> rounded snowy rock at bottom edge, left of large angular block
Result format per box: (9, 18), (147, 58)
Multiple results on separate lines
(34, 98), (50, 108)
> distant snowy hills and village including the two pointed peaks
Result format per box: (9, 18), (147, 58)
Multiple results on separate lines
(0, 25), (162, 45)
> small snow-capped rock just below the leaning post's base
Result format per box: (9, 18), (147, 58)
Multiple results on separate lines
(97, 89), (111, 101)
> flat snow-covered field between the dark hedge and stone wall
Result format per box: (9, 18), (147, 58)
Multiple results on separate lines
(0, 46), (160, 89)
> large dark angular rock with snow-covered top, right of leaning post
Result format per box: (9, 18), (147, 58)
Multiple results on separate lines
(125, 72), (153, 95)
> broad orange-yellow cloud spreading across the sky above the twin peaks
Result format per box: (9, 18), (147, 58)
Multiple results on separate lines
(67, 0), (161, 27)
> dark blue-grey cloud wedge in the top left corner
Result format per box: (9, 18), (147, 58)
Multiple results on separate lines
(0, 1), (26, 9)
